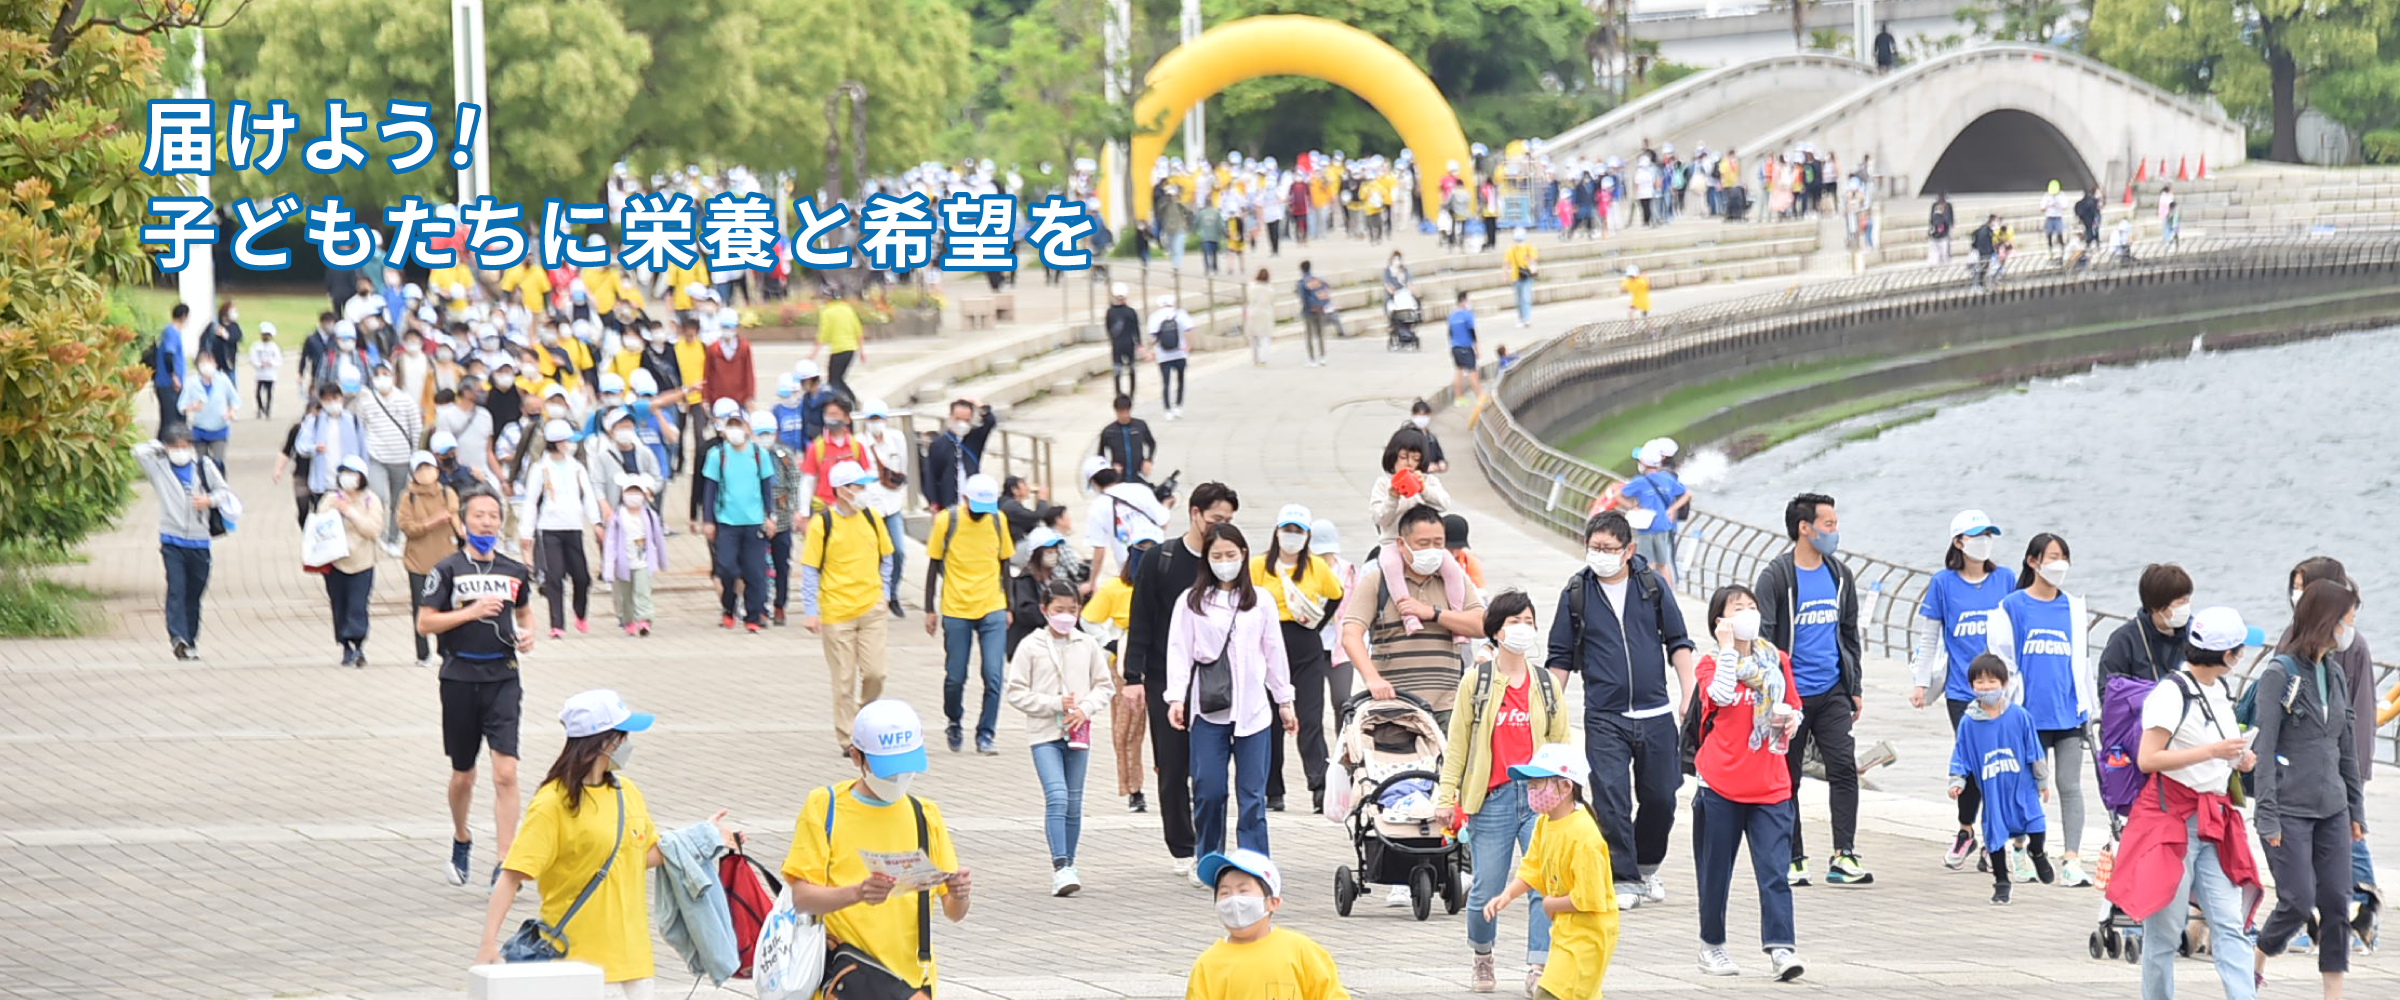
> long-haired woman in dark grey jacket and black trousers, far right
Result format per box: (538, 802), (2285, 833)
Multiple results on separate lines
(2251, 580), (2366, 998)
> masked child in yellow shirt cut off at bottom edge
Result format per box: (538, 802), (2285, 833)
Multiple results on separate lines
(1183, 849), (1349, 1000)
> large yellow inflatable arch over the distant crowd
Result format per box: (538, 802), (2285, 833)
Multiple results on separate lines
(1128, 14), (1469, 221)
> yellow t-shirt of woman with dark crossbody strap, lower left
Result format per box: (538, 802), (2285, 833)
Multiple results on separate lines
(502, 777), (658, 983)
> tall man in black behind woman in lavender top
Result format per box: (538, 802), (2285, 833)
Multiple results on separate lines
(1121, 482), (1241, 875)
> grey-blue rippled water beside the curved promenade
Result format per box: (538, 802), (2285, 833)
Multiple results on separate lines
(1687, 329), (2400, 633)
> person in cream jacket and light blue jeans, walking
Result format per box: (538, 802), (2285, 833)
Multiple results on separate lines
(1001, 580), (1114, 897)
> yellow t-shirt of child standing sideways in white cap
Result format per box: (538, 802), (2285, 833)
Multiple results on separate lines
(1517, 808), (1618, 1000)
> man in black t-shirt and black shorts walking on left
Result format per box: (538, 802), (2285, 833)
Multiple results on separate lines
(418, 492), (533, 885)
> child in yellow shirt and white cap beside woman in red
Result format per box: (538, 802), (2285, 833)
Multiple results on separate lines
(1483, 743), (1618, 1000)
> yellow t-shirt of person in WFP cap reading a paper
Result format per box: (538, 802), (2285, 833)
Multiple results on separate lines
(782, 779), (958, 988)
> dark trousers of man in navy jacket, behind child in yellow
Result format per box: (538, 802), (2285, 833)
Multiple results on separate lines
(1584, 712), (1682, 882)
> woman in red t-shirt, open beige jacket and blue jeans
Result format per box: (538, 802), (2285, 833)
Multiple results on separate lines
(1433, 590), (1574, 993)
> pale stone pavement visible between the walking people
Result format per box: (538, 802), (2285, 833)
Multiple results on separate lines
(0, 273), (2400, 1000)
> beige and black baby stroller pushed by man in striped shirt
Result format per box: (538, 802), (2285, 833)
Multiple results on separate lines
(1327, 693), (1466, 921)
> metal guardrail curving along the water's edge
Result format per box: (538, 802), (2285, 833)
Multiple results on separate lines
(1474, 237), (2400, 765)
